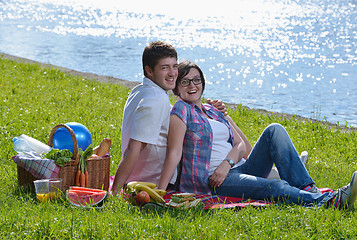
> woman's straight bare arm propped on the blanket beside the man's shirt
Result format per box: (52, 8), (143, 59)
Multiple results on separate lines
(158, 115), (186, 189)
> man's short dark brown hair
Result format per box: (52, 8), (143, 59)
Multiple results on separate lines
(142, 41), (177, 77)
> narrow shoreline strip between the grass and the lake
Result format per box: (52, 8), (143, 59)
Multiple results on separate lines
(0, 52), (357, 132)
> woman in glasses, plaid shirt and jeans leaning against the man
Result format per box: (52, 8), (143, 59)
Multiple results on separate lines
(159, 61), (357, 209)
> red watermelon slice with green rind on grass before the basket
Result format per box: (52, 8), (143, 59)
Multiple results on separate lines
(66, 188), (108, 208)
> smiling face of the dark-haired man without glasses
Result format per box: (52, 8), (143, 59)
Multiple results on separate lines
(145, 57), (178, 91)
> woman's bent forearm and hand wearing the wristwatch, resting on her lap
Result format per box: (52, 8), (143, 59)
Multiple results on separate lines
(210, 121), (246, 188)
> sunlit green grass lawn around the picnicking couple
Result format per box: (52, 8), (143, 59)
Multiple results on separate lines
(0, 56), (357, 239)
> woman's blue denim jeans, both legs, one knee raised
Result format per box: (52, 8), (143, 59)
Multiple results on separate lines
(210, 124), (334, 206)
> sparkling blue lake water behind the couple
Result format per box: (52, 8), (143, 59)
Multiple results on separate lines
(0, 0), (357, 126)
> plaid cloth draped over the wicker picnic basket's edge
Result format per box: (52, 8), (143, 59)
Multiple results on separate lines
(12, 155), (60, 179)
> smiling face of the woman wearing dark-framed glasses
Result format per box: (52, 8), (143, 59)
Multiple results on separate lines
(177, 68), (203, 106)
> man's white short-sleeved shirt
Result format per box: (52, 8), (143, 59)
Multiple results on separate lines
(121, 78), (176, 184)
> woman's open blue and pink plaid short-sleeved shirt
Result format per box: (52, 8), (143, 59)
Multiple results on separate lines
(171, 99), (234, 194)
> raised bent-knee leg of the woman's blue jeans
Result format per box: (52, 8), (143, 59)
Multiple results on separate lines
(239, 123), (314, 188)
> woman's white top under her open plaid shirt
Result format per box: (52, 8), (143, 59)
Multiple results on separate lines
(208, 119), (245, 176)
